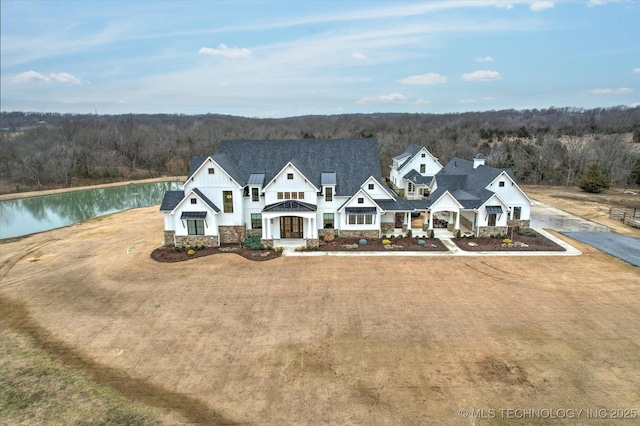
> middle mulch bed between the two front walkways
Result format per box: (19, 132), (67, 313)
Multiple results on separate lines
(318, 238), (448, 251)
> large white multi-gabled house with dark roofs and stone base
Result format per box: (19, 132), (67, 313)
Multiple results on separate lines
(160, 139), (531, 247)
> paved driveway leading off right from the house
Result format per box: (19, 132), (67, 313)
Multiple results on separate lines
(531, 201), (640, 267)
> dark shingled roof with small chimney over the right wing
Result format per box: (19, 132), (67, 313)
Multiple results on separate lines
(426, 157), (515, 209)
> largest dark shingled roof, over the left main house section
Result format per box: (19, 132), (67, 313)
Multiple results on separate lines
(198, 139), (382, 195)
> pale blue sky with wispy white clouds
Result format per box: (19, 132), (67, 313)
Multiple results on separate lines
(0, 0), (640, 118)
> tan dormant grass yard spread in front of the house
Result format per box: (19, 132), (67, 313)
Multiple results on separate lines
(0, 192), (640, 425)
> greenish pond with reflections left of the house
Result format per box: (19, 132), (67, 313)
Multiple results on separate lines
(0, 182), (182, 239)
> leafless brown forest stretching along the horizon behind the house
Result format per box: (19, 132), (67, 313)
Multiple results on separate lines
(0, 107), (640, 191)
